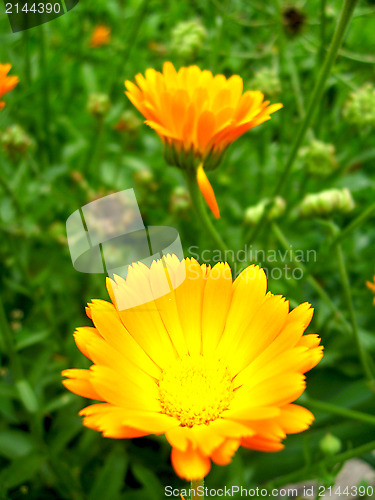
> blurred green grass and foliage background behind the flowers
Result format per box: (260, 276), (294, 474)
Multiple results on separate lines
(0, 0), (375, 500)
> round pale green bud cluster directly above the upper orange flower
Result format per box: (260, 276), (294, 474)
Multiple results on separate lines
(170, 19), (207, 61)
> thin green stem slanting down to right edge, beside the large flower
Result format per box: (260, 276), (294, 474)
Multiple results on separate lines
(335, 229), (375, 382)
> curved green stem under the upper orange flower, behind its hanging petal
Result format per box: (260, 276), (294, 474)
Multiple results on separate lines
(186, 170), (234, 267)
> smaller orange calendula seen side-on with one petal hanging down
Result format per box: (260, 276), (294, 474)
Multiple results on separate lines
(125, 62), (282, 216)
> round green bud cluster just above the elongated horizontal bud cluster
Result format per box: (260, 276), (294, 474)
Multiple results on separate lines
(299, 139), (337, 177)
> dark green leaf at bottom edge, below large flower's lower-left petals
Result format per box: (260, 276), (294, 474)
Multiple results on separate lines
(89, 446), (128, 500)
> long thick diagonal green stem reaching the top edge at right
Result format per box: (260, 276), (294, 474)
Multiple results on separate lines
(249, 0), (358, 243)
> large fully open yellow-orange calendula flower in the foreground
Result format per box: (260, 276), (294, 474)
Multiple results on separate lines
(63, 255), (323, 480)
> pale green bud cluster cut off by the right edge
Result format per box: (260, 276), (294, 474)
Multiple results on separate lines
(343, 83), (375, 128)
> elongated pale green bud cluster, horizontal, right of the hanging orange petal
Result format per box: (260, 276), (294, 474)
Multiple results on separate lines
(299, 188), (355, 217)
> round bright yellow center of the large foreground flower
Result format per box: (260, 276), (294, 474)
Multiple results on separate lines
(158, 355), (234, 427)
